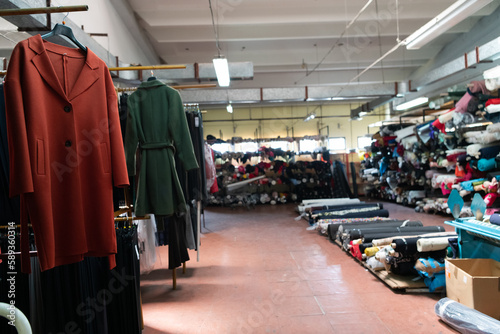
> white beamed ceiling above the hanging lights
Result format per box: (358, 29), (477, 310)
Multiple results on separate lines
(128, 0), (499, 88)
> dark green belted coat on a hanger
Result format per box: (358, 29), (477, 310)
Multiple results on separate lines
(125, 80), (198, 216)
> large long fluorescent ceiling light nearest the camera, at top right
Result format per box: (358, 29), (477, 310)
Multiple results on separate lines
(405, 0), (493, 50)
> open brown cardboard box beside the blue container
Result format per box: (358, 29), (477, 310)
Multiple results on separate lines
(446, 259), (500, 319)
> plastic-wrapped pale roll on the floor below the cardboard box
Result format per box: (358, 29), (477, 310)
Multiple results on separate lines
(434, 298), (500, 334)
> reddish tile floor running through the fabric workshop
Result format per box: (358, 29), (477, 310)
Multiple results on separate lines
(141, 203), (456, 334)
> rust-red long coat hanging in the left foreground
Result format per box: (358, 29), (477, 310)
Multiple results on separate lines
(5, 35), (129, 271)
